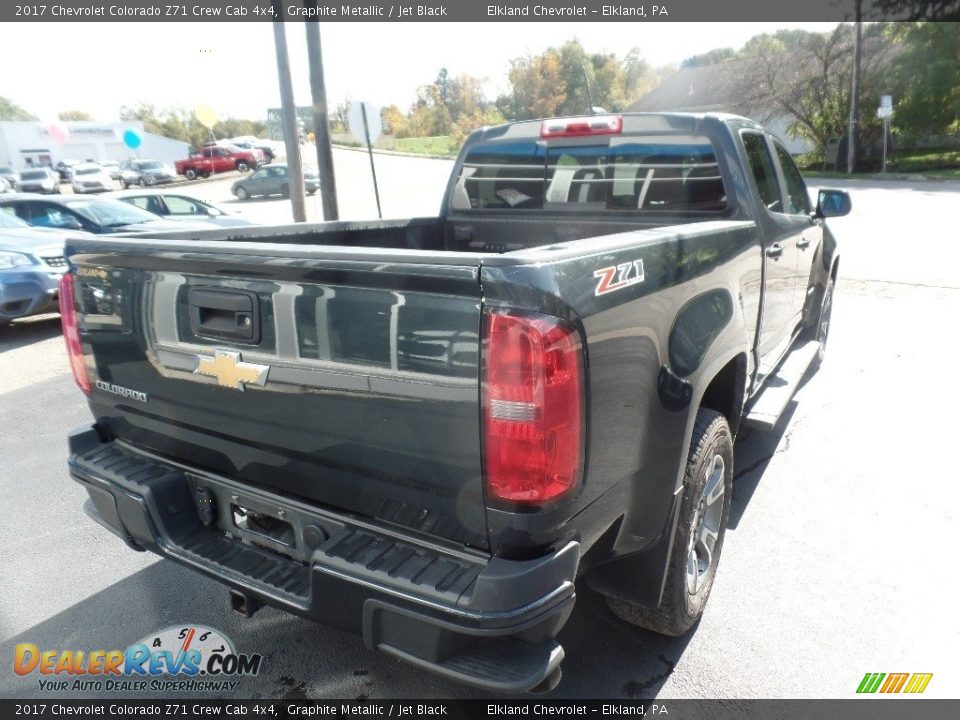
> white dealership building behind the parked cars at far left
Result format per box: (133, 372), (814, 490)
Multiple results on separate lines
(0, 120), (190, 170)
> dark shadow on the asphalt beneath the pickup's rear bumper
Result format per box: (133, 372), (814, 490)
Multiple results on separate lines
(0, 552), (690, 701)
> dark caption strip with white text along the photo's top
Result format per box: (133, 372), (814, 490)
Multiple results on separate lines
(0, 0), (960, 22)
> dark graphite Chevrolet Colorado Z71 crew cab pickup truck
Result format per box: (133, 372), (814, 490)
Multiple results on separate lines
(61, 114), (850, 692)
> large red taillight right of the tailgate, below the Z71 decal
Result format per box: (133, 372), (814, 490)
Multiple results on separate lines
(483, 313), (583, 505)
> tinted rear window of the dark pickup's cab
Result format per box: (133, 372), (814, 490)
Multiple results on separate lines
(452, 134), (727, 212)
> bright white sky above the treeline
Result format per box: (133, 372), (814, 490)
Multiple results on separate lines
(0, 22), (834, 122)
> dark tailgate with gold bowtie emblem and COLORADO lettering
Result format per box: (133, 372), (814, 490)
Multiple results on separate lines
(68, 240), (488, 549)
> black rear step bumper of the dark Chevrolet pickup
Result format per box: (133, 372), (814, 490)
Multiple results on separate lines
(69, 428), (579, 692)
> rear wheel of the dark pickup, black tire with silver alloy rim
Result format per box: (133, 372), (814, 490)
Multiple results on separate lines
(607, 408), (733, 637)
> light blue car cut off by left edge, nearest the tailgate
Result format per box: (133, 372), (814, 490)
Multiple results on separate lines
(0, 205), (85, 326)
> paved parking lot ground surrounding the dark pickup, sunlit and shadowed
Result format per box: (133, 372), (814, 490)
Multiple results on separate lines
(0, 156), (960, 699)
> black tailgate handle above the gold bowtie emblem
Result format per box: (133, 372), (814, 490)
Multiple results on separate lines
(190, 288), (260, 345)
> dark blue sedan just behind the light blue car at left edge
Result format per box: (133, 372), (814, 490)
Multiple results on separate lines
(0, 195), (216, 235)
